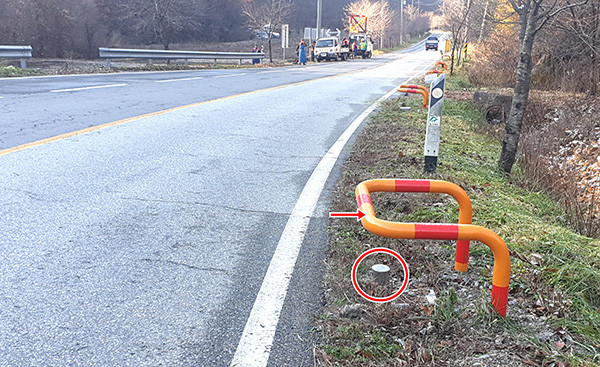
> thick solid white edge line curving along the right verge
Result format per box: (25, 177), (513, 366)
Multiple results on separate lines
(230, 61), (429, 367)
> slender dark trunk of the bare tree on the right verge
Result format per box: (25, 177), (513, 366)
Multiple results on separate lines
(499, 13), (537, 174)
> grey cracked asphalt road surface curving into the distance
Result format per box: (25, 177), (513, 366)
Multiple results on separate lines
(0, 38), (439, 366)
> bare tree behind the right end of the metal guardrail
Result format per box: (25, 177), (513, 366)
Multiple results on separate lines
(242, 0), (292, 62)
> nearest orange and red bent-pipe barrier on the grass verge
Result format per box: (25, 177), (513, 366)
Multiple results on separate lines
(356, 179), (510, 317)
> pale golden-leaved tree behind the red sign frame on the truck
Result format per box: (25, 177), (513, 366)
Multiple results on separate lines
(344, 0), (395, 47)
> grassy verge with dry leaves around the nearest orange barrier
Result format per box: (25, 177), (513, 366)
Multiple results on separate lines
(317, 74), (600, 366)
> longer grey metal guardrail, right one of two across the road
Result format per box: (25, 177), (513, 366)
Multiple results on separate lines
(98, 47), (265, 68)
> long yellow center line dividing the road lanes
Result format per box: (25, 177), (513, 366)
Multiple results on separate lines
(0, 60), (394, 156)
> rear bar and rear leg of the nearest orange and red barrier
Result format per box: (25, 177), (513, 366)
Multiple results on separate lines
(356, 179), (473, 271)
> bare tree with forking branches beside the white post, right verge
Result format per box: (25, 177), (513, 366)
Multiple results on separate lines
(499, 0), (584, 174)
